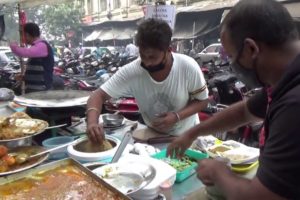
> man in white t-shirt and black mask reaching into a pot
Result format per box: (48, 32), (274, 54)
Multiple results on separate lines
(87, 19), (208, 142)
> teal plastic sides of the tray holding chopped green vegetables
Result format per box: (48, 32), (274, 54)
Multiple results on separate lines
(152, 149), (208, 183)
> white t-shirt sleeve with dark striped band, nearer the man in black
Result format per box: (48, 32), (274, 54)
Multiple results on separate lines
(187, 59), (208, 100)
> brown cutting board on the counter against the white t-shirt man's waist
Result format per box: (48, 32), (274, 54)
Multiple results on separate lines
(132, 128), (176, 144)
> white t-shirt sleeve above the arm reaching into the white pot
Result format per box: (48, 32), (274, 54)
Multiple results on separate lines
(100, 63), (134, 98)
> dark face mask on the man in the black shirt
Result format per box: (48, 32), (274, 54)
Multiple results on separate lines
(231, 48), (264, 89)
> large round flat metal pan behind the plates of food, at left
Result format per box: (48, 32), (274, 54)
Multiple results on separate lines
(14, 90), (91, 108)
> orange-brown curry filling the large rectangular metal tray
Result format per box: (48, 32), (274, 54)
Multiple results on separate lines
(0, 165), (124, 200)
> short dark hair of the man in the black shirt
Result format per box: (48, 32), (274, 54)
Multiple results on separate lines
(221, 0), (298, 49)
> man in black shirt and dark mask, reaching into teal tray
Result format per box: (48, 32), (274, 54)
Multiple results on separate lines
(168, 0), (300, 200)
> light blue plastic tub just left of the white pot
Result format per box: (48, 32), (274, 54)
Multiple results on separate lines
(42, 136), (74, 160)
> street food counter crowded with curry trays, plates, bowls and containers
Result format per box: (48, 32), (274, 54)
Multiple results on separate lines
(0, 1), (259, 200)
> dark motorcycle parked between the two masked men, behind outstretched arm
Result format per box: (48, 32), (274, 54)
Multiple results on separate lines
(199, 63), (261, 147)
